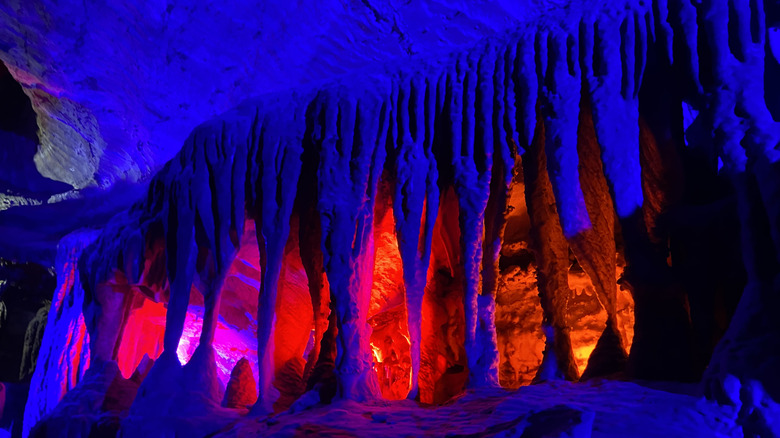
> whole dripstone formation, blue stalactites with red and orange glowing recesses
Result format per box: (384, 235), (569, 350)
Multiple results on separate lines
(21, 1), (780, 436)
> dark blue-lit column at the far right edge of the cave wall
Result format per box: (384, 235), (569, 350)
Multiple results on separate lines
(700, 0), (780, 404)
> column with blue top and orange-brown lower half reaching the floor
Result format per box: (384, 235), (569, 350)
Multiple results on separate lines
(523, 29), (591, 380)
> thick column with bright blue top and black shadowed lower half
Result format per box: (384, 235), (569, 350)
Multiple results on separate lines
(582, 12), (693, 379)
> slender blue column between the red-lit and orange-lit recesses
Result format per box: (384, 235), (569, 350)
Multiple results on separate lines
(447, 48), (498, 387)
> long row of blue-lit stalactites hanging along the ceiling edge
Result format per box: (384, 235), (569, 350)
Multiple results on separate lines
(83, 0), (774, 406)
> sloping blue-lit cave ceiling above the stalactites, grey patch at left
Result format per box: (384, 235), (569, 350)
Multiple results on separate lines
(0, 0), (580, 260)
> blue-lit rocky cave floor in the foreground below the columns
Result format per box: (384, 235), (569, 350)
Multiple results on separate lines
(211, 380), (742, 438)
